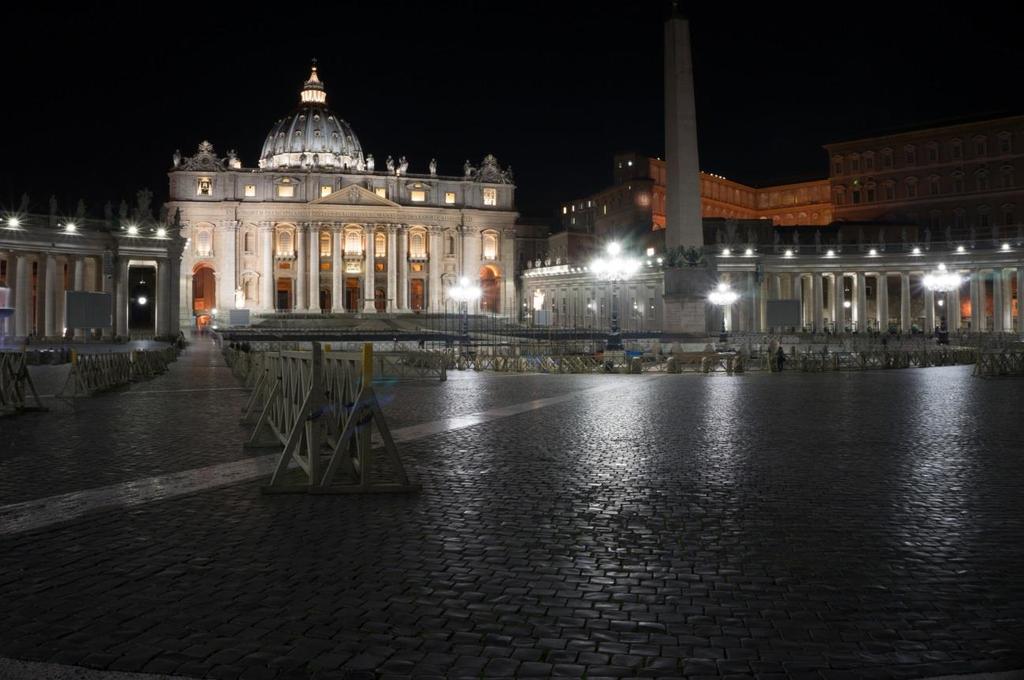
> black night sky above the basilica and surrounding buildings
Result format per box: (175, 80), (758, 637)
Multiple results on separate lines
(0, 0), (1024, 217)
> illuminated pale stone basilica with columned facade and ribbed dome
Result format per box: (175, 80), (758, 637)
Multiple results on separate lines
(168, 67), (517, 328)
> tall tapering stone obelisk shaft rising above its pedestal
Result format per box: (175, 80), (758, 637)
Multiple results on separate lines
(665, 2), (703, 249)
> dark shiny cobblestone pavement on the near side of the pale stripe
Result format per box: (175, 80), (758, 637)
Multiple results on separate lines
(0, 346), (1024, 680)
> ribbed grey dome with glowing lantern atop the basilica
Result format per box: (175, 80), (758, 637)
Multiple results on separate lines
(259, 66), (365, 171)
